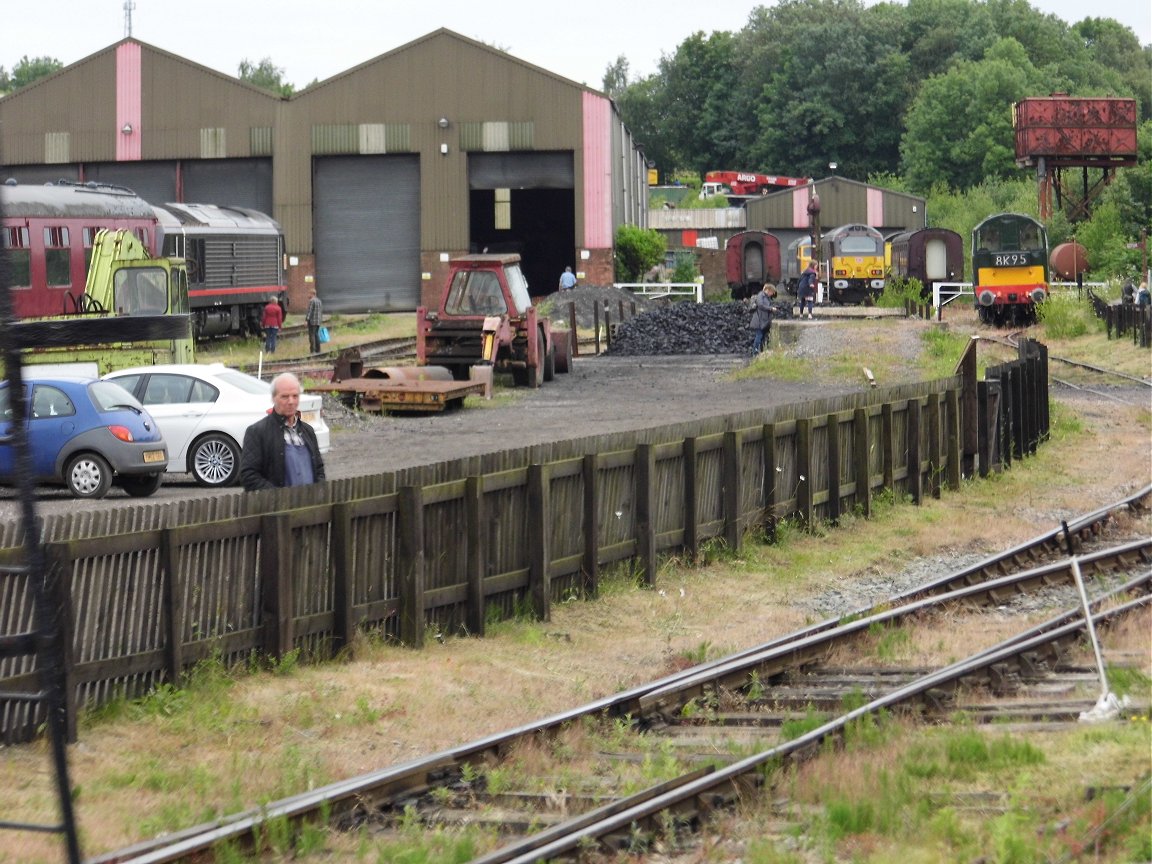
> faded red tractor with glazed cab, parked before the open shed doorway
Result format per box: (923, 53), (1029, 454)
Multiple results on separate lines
(416, 255), (571, 387)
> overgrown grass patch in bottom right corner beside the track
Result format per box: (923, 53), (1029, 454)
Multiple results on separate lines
(748, 722), (1152, 864)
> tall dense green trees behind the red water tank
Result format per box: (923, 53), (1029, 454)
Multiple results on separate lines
(604, 0), (1152, 194)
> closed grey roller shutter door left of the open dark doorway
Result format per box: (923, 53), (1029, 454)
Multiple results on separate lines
(312, 156), (420, 312)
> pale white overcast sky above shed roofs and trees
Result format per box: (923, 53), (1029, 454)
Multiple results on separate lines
(0, 0), (1152, 89)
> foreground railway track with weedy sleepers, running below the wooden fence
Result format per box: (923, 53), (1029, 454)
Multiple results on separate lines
(96, 486), (1152, 864)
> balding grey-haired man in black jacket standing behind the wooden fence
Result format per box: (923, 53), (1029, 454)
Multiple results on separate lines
(240, 372), (324, 492)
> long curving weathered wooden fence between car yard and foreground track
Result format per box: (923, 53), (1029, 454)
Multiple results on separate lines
(0, 342), (1047, 742)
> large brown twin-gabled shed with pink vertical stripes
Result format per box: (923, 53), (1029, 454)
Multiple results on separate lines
(0, 30), (647, 312)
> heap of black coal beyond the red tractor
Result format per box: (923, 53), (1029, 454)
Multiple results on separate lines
(606, 301), (791, 357)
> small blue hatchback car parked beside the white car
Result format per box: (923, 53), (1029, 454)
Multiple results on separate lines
(0, 378), (168, 499)
